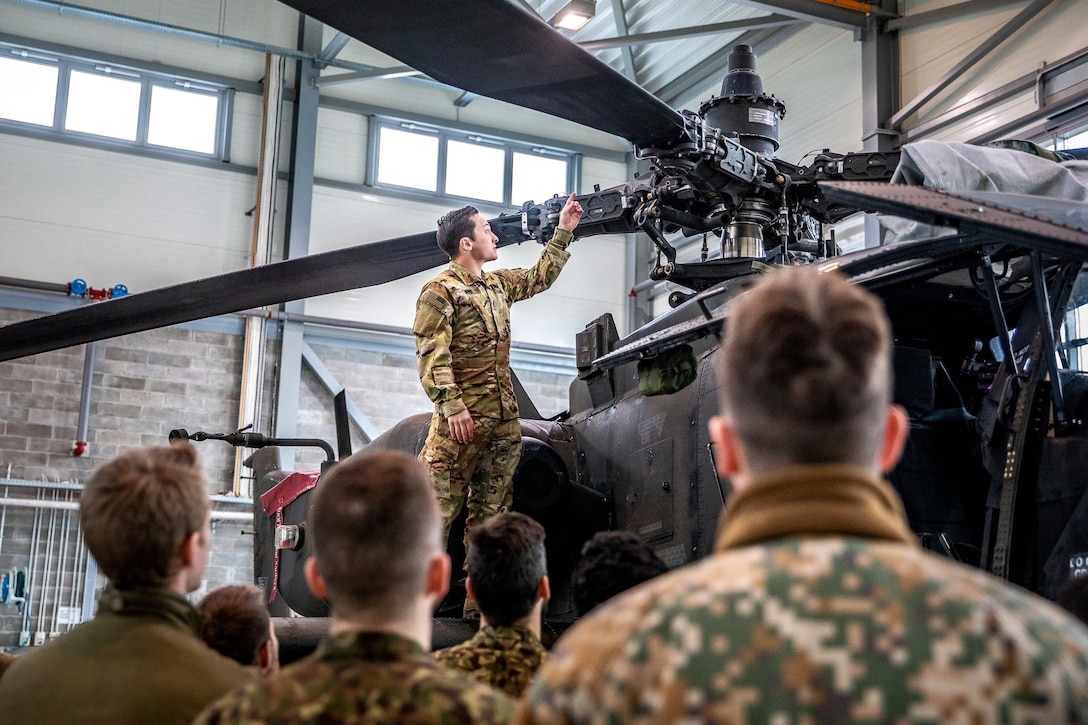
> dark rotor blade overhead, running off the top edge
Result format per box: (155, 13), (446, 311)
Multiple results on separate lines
(282, 0), (684, 148)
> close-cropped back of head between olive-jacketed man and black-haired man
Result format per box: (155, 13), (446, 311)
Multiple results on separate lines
(309, 451), (442, 616)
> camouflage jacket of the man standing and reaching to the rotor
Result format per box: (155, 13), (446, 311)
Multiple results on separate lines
(412, 229), (571, 420)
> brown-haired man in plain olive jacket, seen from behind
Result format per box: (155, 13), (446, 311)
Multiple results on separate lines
(0, 442), (254, 723)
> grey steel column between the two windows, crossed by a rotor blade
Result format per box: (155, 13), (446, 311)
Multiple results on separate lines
(273, 15), (322, 468)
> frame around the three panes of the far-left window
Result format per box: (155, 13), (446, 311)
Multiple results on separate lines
(0, 41), (234, 162)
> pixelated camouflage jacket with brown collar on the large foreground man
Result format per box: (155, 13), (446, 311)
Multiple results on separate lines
(516, 466), (1088, 725)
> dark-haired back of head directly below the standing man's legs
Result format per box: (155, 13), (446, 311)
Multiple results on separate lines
(467, 512), (547, 627)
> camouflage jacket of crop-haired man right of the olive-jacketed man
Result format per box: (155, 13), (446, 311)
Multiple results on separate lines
(196, 631), (512, 724)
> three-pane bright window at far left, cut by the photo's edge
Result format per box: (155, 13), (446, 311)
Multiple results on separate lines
(0, 44), (231, 160)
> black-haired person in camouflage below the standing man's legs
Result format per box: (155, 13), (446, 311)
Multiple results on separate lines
(434, 512), (552, 697)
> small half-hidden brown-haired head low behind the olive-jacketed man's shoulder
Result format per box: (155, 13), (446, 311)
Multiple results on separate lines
(197, 585), (280, 674)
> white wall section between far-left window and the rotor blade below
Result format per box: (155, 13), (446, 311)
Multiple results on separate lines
(0, 134), (269, 292)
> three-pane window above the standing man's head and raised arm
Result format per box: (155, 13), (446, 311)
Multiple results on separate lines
(367, 119), (578, 207)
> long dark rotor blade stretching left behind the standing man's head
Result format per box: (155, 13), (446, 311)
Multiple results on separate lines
(0, 232), (448, 360)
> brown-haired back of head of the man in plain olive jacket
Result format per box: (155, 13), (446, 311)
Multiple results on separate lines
(79, 443), (211, 588)
